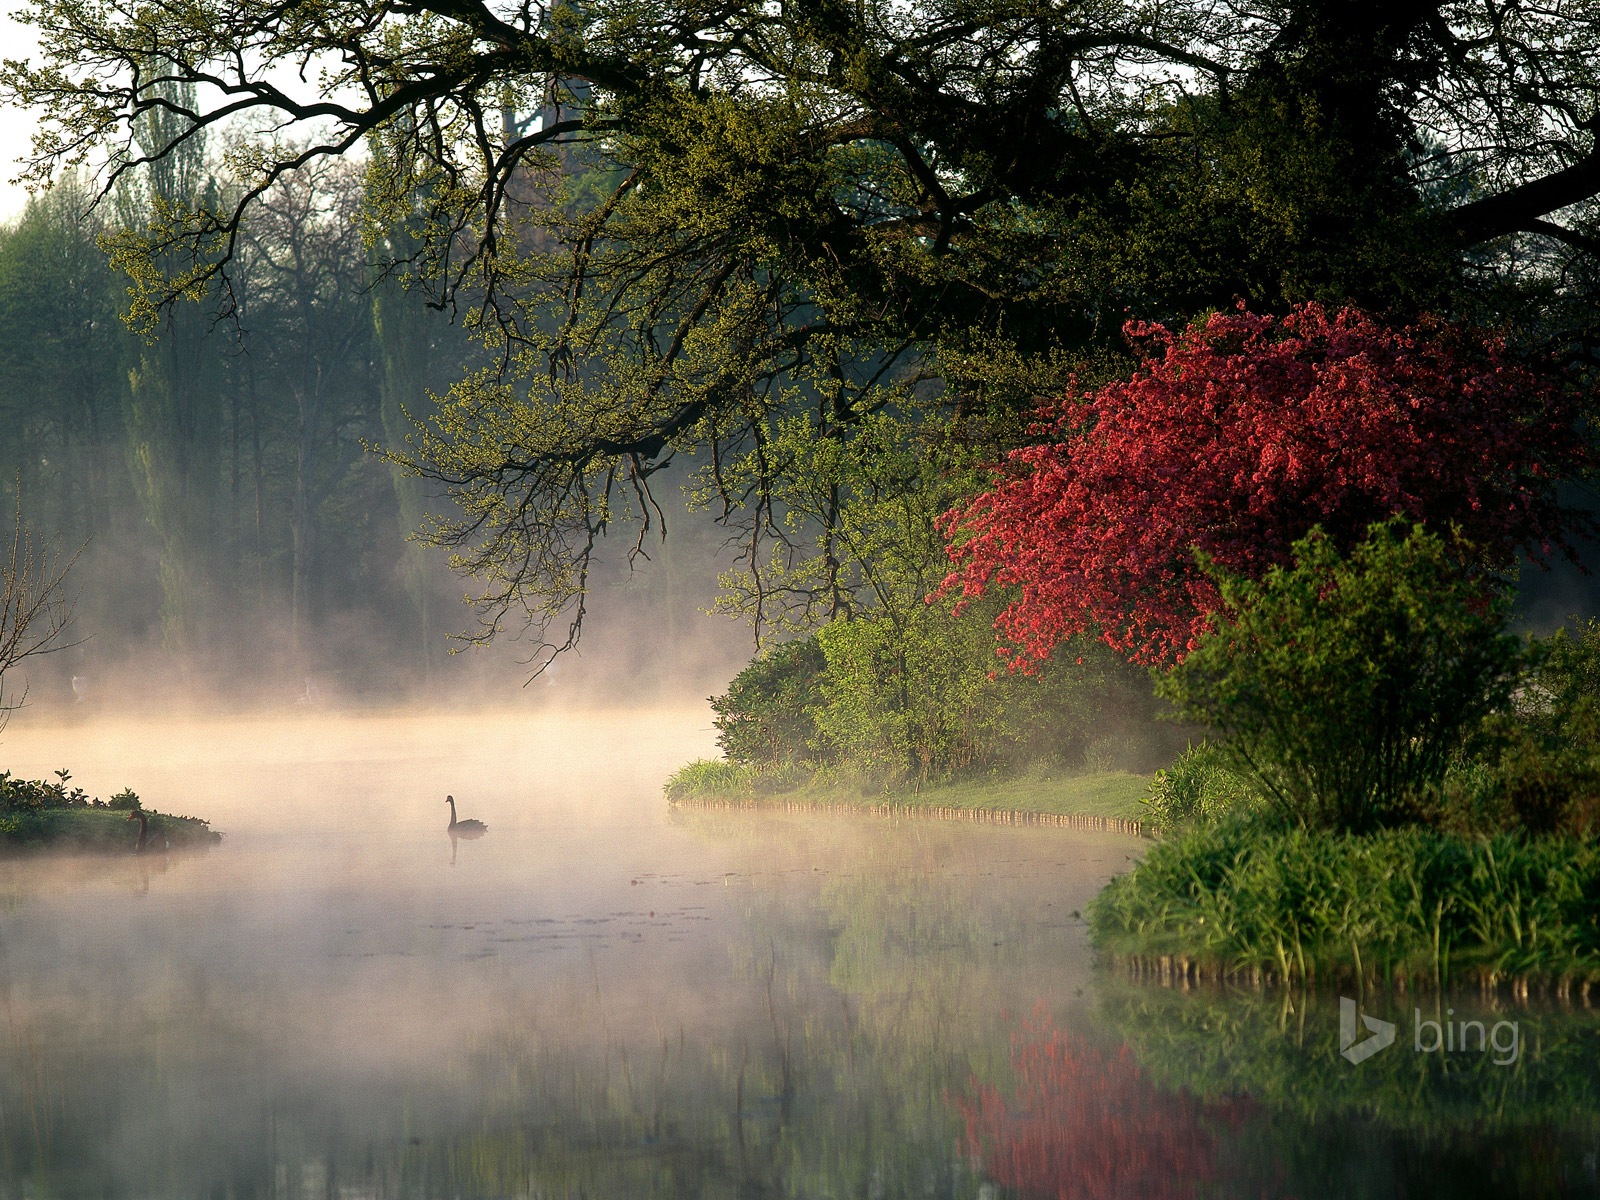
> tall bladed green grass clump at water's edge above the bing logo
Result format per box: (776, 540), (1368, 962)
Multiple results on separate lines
(1090, 822), (1600, 984)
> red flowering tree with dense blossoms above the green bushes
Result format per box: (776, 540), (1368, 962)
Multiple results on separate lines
(941, 304), (1592, 669)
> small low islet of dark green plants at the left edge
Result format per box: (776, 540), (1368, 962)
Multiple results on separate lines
(0, 771), (222, 856)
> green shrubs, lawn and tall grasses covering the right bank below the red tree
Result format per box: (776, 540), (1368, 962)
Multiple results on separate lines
(666, 544), (1600, 1005)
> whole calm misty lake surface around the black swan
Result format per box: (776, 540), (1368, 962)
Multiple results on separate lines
(0, 712), (1600, 1200)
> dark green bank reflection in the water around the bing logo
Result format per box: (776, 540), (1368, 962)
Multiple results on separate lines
(1096, 979), (1600, 1197)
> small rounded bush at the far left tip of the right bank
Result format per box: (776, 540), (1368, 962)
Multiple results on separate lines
(710, 637), (827, 770)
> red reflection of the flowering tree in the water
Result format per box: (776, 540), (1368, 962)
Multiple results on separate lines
(962, 1011), (1245, 1200)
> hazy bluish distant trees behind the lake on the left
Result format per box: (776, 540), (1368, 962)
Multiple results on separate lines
(0, 148), (470, 694)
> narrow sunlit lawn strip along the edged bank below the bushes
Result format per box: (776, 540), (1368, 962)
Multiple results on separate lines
(664, 760), (1150, 832)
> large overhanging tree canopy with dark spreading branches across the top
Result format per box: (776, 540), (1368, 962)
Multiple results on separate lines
(0, 0), (1600, 659)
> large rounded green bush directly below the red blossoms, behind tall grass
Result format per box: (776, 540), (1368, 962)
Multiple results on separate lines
(1157, 522), (1523, 830)
